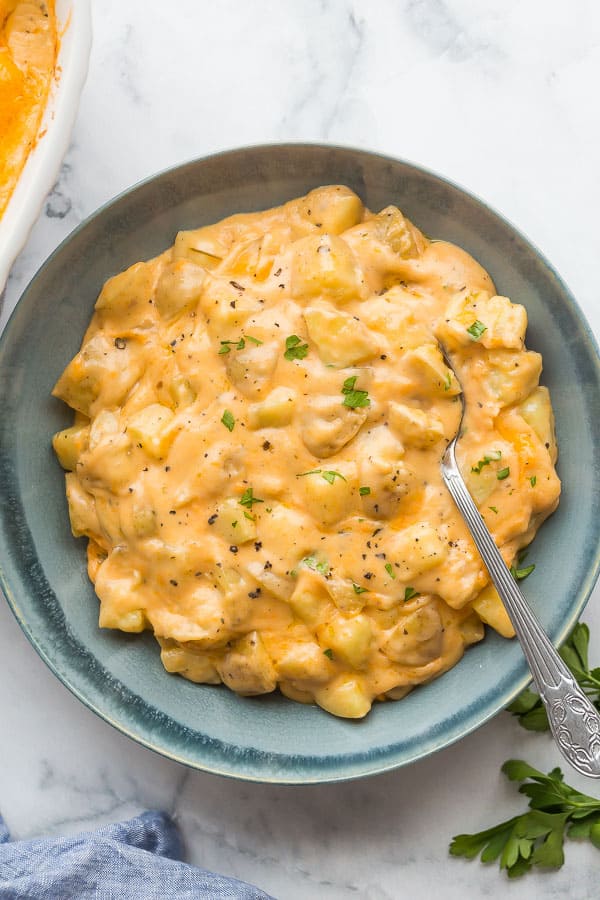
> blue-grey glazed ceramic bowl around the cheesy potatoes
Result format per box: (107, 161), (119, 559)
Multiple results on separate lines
(0, 145), (600, 783)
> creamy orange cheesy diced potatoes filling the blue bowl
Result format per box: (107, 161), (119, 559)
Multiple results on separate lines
(54, 186), (560, 718)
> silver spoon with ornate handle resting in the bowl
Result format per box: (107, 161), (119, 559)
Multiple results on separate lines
(440, 347), (600, 778)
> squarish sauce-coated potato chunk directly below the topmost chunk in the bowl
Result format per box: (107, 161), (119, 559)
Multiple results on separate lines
(291, 234), (363, 303)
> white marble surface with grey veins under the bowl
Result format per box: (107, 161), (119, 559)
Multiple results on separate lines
(0, 0), (600, 900)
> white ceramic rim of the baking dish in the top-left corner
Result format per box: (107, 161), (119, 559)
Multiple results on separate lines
(0, 0), (92, 295)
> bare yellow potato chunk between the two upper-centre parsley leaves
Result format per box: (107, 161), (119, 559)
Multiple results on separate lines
(304, 306), (378, 366)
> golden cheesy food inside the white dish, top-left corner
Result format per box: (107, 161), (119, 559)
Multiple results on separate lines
(0, 0), (58, 216)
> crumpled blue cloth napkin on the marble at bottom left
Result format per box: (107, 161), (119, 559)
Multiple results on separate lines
(0, 812), (273, 900)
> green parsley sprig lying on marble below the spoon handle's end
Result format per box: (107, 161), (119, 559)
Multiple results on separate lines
(449, 759), (600, 878)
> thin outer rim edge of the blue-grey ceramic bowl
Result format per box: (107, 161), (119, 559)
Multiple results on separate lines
(0, 141), (600, 785)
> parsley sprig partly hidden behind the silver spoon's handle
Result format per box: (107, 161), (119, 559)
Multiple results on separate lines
(507, 624), (600, 731)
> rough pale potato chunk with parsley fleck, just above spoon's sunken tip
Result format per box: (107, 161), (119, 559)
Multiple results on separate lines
(439, 291), (527, 350)
